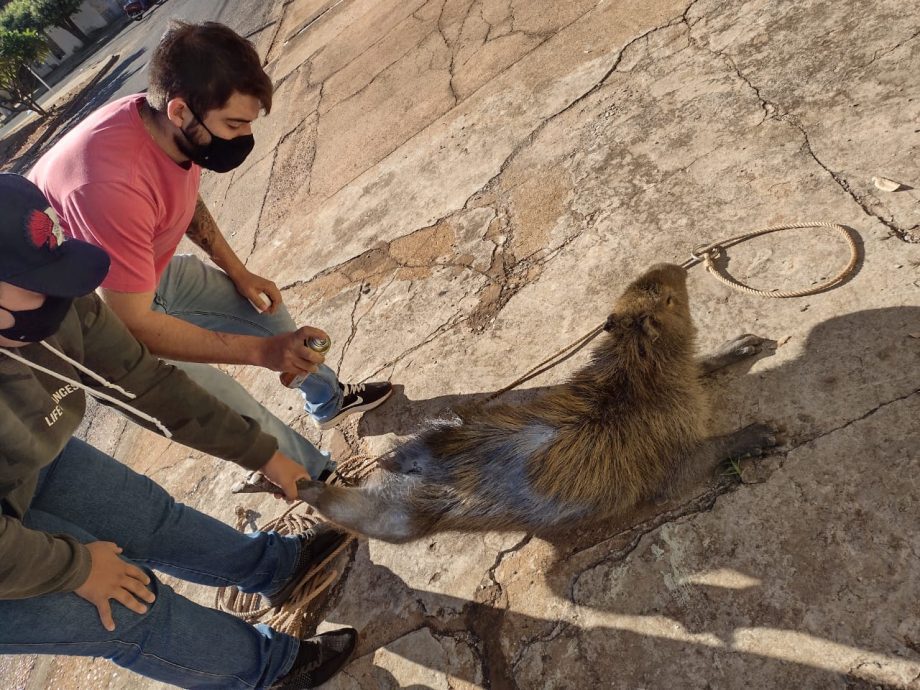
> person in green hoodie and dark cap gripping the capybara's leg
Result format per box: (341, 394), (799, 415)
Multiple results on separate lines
(0, 174), (357, 690)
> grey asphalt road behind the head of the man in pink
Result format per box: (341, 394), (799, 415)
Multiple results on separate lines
(0, 0), (273, 137)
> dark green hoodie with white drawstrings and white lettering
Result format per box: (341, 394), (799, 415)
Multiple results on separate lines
(0, 294), (278, 599)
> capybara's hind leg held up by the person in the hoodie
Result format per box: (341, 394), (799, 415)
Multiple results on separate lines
(297, 479), (420, 543)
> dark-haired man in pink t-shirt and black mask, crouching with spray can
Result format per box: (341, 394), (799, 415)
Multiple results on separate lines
(29, 22), (392, 478)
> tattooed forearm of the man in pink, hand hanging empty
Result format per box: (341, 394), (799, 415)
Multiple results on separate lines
(185, 196), (282, 314)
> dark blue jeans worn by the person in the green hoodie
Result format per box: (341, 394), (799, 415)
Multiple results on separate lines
(0, 439), (300, 690)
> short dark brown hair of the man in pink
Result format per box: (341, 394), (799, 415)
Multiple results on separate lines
(147, 20), (273, 117)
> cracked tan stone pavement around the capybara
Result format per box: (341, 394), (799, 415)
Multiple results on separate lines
(4, 0), (920, 690)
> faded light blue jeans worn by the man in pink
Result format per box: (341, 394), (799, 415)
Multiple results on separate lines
(153, 255), (342, 478)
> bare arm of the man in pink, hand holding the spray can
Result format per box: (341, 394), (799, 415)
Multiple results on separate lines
(100, 288), (325, 373)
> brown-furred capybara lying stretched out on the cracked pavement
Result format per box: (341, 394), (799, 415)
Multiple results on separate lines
(299, 264), (771, 542)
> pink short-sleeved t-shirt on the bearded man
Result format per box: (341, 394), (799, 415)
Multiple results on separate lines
(28, 94), (201, 292)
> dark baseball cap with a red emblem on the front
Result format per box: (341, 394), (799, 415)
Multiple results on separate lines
(0, 173), (109, 297)
